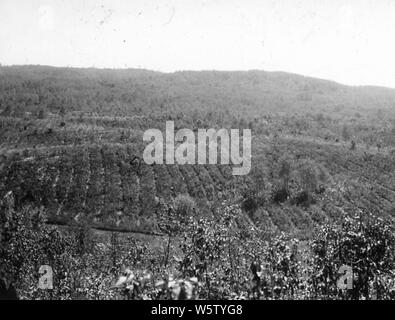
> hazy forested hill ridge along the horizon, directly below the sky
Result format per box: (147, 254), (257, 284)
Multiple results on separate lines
(0, 66), (395, 117)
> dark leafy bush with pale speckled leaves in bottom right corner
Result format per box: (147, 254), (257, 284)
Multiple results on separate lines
(310, 213), (395, 299)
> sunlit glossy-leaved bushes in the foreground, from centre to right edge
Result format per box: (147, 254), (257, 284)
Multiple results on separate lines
(113, 202), (395, 299)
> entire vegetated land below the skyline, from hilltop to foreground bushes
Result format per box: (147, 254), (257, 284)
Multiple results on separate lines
(0, 66), (395, 299)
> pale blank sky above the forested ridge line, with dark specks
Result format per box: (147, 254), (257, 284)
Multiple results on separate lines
(0, 0), (395, 88)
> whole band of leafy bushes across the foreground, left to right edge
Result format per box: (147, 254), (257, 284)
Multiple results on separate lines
(1, 192), (395, 299)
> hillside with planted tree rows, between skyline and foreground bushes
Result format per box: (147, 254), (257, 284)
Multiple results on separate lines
(0, 66), (395, 298)
